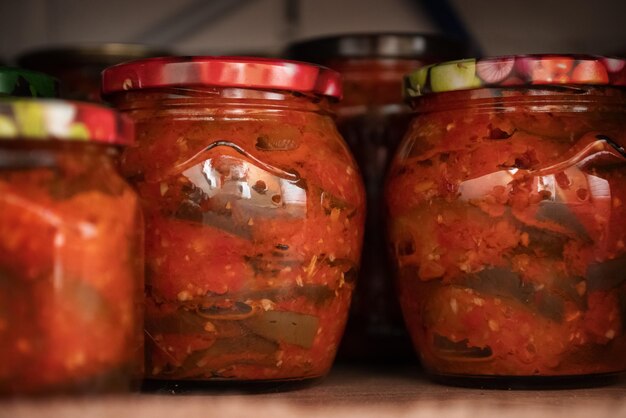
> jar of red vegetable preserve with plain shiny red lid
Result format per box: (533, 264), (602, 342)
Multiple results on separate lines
(103, 57), (364, 381)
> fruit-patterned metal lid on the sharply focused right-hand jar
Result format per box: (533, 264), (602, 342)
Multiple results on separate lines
(405, 54), (626, 96)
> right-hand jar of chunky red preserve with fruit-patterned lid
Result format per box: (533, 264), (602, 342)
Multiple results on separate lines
(386, 55), (626, 385)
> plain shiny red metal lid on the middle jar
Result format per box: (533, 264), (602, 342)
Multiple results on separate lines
(102, 57), (342, 99)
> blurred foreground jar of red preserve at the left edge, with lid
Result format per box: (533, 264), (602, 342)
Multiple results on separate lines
(0, 99), (143, 396)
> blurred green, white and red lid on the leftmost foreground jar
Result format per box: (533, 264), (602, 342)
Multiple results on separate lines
(0, 98), (134, 145)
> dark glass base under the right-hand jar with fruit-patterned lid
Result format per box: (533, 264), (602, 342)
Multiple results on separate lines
(428, 373), (625, 390)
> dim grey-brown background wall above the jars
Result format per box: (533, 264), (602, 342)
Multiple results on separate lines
(0, 0), (626, 60)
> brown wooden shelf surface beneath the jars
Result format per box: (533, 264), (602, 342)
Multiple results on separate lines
(0, 365), (626, 418)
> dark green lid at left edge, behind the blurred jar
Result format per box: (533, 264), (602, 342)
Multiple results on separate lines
(0, 67), (59, 97)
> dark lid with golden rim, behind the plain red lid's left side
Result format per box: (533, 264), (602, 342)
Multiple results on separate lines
(17, 43), (170, 70)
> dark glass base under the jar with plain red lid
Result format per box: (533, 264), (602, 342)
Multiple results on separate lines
(141, 376), (324, 395)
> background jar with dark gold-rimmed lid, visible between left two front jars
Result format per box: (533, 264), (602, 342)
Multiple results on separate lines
(17, 43), (169, 102)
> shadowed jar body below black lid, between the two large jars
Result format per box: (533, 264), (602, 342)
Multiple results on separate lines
(326, 58), (421, 362)
